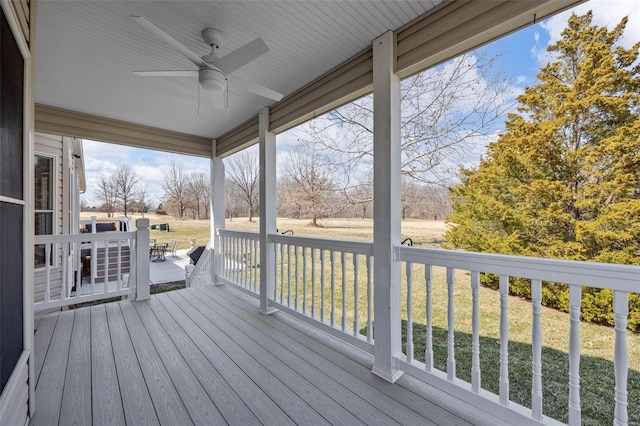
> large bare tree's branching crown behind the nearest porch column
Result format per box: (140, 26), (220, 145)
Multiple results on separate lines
(296, 50), (513, 204)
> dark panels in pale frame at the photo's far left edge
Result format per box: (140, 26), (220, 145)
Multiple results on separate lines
(0, 12), (24, 392)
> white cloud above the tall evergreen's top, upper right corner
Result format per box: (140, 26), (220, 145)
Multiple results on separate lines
(532, 0), (640, 66)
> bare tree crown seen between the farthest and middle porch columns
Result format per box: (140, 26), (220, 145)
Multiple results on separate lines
(225, 150), (260, 222)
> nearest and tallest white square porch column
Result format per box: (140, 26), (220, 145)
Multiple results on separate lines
(373, 31), (402, 383)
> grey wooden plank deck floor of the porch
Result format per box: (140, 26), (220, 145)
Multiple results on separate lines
(31, 286), (496, 425)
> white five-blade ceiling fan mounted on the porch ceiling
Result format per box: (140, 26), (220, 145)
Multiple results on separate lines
(131, 15), (283, 109)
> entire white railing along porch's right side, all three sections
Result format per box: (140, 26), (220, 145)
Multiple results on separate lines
(204, 230), (640, 425)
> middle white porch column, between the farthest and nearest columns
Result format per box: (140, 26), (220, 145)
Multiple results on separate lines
(258, 107), (276, 315)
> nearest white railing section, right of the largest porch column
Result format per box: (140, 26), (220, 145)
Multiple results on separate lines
(395, 246), (640, 425)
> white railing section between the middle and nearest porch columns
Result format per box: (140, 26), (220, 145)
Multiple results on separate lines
(269, 234), (373, 352)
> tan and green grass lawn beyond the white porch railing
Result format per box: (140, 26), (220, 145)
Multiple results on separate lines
(83, 213), (640, 425)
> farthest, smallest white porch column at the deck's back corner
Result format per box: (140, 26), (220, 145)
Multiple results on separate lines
(209, 140), (226, 285)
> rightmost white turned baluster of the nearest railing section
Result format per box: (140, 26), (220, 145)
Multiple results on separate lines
(613, 291), (629, 426)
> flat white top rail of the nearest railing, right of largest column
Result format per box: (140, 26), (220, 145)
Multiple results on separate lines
(395, 246), (640, 292)
